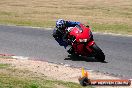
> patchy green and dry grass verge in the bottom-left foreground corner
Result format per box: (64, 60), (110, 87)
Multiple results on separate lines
(0, 64), (93, 88)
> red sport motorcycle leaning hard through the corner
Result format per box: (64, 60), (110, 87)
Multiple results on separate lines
(67, 24), (105, 62)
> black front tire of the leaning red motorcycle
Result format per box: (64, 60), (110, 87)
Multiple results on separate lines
(91, 44), (105, 62)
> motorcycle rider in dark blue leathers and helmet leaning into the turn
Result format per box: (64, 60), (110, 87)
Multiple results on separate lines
(53, 19), (80, 54)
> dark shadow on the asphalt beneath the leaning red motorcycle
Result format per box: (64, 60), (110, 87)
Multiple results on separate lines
(64, 55), (108, 63)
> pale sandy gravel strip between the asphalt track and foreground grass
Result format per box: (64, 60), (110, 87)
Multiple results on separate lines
(0, 58), (132, 88)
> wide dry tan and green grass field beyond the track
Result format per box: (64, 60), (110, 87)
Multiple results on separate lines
(0, 0), (132, 34)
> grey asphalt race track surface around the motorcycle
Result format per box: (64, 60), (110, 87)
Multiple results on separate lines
(0, 25), (132, 79)
